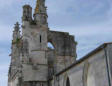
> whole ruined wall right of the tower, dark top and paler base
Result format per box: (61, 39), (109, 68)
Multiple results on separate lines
(48, 31), (77, 72)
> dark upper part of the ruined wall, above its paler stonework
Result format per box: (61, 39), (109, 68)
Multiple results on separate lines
(48, 31), (76, 58)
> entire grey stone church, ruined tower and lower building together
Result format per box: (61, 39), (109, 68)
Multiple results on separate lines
(8, 0), (112, 86)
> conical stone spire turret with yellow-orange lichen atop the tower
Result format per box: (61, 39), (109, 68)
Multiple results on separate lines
(34, 0), (48, 26)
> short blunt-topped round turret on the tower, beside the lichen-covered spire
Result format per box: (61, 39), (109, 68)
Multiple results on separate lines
(22, 5), (32, 21)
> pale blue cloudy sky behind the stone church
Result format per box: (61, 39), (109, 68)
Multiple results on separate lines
(0, 0), (112, 86)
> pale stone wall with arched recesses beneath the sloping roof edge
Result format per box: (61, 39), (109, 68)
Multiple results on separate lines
(52, 49), (109, 86)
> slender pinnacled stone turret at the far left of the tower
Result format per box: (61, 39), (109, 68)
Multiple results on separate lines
(8, 22), (21, 86)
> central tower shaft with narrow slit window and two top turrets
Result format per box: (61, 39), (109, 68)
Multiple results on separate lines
(22, 0), (48, 86)
